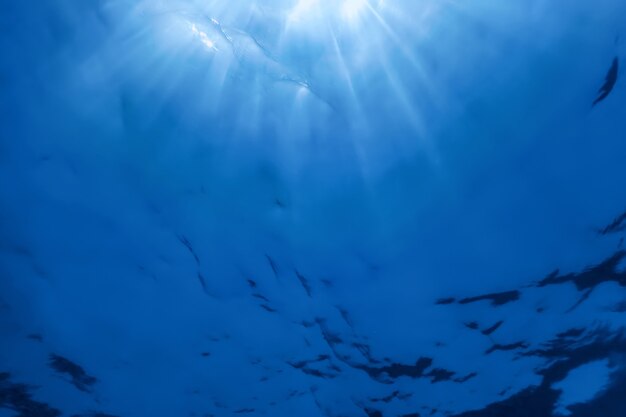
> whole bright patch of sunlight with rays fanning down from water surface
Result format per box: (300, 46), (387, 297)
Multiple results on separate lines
(139, 0), (449, 161)
